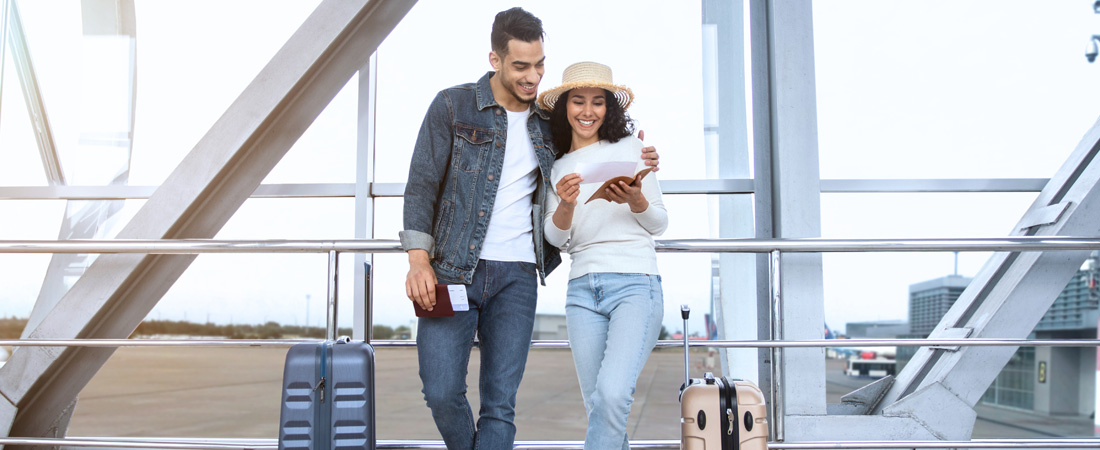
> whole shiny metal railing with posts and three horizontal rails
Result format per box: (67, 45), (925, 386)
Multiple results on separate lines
(0, 237), (1100, 450)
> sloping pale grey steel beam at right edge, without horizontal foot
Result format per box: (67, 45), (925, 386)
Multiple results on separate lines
(878, 114), (1100, 431)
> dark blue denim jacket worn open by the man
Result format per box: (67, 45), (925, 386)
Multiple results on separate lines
(399, 72), (561, 285)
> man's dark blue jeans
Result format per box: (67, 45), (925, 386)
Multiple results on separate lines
(417, 260), (537, 450)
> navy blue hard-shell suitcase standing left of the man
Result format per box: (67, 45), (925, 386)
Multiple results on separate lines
(278, 338), (375, 450)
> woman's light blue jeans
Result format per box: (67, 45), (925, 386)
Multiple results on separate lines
(565, 273), (664, 450)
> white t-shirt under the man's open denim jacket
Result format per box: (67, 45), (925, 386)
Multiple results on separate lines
(481, 110), (539, 263)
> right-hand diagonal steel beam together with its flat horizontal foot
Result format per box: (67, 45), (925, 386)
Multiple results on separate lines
(785, 121), (1100, 442)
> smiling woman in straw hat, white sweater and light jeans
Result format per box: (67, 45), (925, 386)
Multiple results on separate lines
(539, 63), (668, 450)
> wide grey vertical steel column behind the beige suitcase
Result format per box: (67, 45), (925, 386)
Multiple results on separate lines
(750, 0), (825, 426)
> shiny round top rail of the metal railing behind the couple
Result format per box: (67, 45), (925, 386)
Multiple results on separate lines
(0, 237), (1100, 254)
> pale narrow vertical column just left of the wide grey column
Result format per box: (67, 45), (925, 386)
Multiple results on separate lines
(703, 0), (767, 383)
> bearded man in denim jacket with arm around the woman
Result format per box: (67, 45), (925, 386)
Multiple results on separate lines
(400, 8), (657, 444)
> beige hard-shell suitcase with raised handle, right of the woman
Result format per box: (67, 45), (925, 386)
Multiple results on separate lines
(680, 305), (768, 450)
